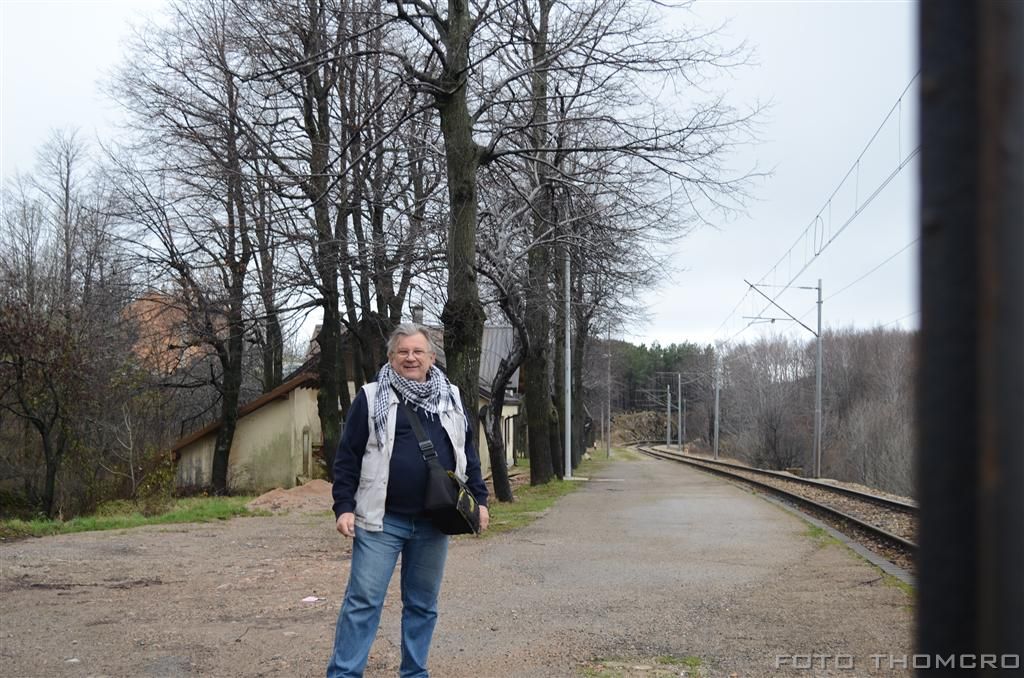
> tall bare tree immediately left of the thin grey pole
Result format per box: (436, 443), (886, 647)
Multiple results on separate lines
(473, 0), (753, 482)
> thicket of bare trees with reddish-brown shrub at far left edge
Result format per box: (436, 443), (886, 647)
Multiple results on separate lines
(0, 131), (160, 516)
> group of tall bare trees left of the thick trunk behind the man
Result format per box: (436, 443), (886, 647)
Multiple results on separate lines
(112, 0), (441, 483)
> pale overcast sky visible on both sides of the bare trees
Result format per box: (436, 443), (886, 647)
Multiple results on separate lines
(0, 0), (918, 344)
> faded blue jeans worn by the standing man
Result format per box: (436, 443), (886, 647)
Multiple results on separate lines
(327, 513), (449, 678)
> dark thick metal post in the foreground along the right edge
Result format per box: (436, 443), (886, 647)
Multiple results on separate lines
(915, 0), (1024, 676)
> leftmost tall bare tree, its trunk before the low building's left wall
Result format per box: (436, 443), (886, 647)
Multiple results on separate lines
(112, 0), (259, 494)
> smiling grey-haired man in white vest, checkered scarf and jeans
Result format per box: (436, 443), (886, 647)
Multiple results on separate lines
(327, 324), (489, 678)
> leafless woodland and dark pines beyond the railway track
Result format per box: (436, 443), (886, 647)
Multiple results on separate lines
(586, 328), (915, 497)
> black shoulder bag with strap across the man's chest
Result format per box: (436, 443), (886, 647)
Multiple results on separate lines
(398, 395), (480, 535)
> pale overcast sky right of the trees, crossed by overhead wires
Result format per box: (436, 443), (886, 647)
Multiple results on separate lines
(638, 1), (919, 344)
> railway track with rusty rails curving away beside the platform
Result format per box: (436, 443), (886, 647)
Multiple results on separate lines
(636, 443), (918, 571)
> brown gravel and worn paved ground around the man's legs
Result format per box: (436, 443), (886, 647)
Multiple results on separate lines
(0, 460), (911, 678)
